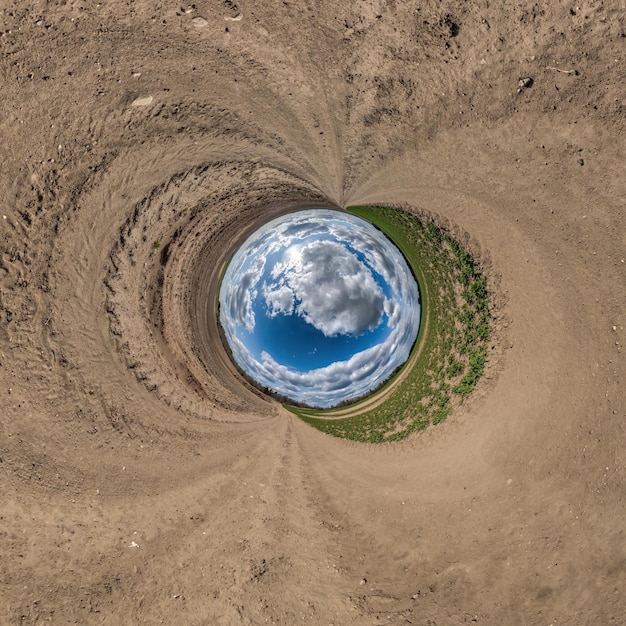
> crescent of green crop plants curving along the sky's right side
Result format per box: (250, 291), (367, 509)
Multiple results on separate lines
(286, 206), (490, 443)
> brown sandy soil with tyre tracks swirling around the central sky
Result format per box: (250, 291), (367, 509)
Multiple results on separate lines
(0, 0), (626, 626)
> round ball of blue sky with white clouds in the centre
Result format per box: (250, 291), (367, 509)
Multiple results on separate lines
(219, 209), (420, 408)
